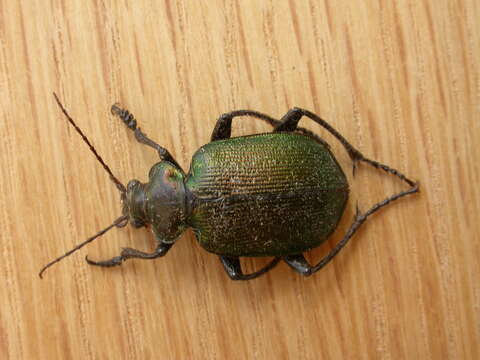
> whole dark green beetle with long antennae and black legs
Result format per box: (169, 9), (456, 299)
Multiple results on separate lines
(39, 93), (419, 280)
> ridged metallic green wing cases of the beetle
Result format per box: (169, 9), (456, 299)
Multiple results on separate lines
(186, 133), (348, 256)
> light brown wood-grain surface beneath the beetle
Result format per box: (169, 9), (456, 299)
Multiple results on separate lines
(0, 0), (480, 359)
